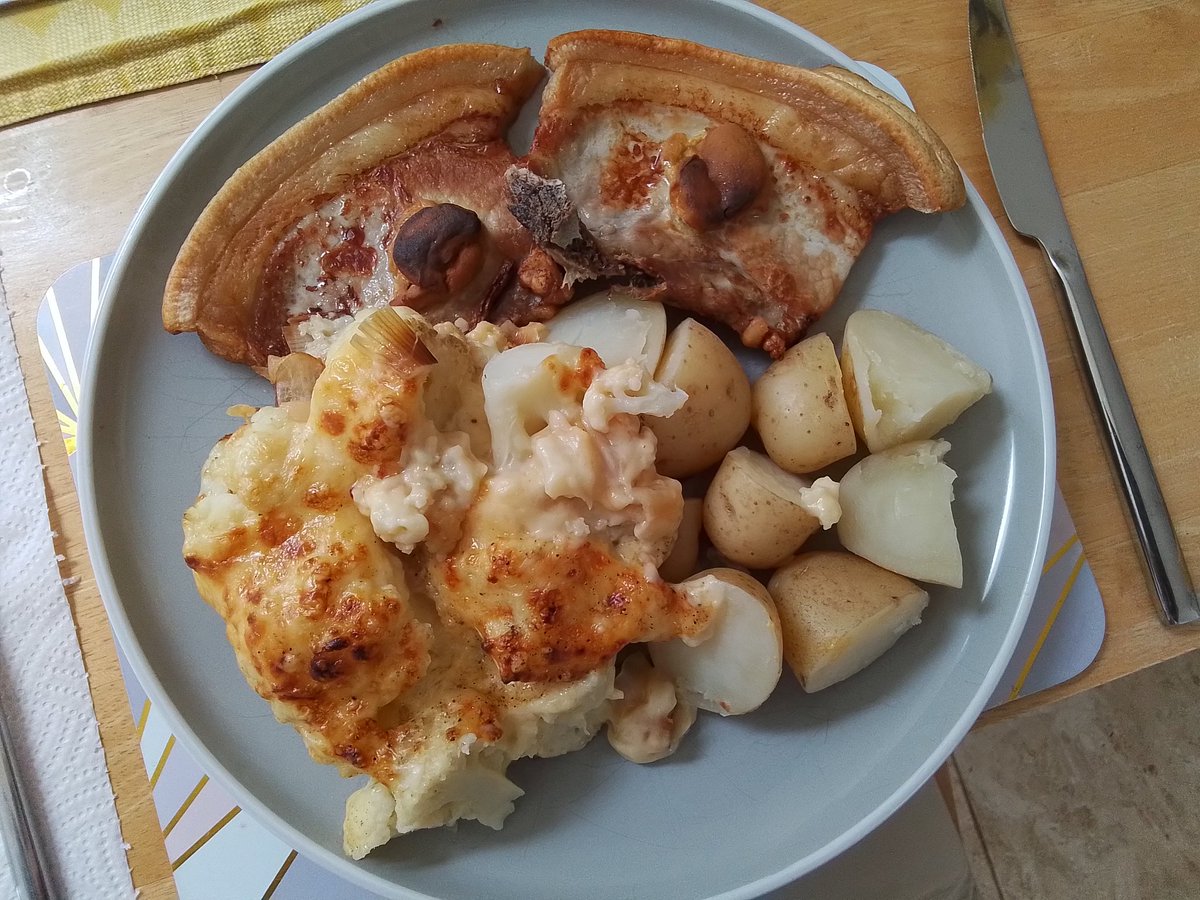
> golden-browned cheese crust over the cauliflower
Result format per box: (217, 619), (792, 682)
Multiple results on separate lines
(184, 310), (712, 785)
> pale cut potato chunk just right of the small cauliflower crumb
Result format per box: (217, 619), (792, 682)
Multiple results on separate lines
(838, 440), (962, 588)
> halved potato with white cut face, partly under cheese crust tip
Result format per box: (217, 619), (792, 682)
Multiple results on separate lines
(648, 569), (784, 715)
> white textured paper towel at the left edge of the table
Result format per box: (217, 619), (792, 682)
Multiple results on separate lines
(0, 287), (133, 898)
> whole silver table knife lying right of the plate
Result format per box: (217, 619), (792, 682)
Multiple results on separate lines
(967, 0), (1200, 625)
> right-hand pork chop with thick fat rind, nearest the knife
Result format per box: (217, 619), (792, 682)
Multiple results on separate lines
(509, 31), (965, 356)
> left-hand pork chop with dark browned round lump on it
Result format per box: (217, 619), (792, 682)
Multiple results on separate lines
(162, 44), (563, 366)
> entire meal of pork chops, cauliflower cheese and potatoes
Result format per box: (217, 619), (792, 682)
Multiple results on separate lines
(163, 31), (990, 858)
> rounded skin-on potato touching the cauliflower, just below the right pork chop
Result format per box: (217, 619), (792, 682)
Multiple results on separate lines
(648, 319), (750, 478)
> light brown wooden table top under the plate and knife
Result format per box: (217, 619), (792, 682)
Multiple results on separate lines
(0, 0), (1200, 898)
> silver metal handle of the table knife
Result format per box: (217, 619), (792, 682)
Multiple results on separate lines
(1042, 241), (1200, 625)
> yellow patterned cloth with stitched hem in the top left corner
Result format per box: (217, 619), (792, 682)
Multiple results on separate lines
(0, 0), (367, 125)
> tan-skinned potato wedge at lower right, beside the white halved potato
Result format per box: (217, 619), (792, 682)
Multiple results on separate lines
(767, 551), (929, 694)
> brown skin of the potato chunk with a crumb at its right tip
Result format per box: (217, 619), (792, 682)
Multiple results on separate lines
(704, 448), (821, 569)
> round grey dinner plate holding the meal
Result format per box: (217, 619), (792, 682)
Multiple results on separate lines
(80, 0), (1054, 898)
